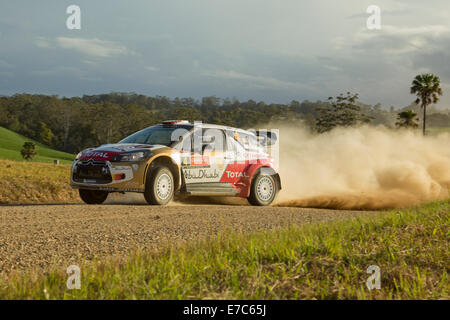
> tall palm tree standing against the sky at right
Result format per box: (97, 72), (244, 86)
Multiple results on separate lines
(411, 73), (442, 135)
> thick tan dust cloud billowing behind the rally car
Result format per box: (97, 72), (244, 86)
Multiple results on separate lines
(270, 125), (450, 210)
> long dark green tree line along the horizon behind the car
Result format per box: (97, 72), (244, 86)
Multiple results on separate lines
(0, 93), (450, 153)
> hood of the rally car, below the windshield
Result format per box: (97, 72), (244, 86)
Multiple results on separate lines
(78, 143), (165, 161)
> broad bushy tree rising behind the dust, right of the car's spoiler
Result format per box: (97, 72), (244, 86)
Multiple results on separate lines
(316, 92), (373, 133)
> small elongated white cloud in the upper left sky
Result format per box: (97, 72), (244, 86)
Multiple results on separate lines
(56, 37), (130, 57)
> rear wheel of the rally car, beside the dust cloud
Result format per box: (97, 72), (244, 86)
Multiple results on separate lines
(247, 173), (278, 206)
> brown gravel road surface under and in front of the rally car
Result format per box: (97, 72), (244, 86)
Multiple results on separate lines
(0, 199), (370, 273)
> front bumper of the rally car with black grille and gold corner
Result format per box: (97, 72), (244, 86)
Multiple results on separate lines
(70, 160), (147, 192)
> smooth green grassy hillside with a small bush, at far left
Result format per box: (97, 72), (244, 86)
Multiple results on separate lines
(0, 127), (75, 163)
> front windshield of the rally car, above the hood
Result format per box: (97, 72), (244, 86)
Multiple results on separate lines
(119, 125), (190, 146)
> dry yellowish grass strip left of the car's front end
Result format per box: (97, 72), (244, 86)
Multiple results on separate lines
(0, 160), (79, 204)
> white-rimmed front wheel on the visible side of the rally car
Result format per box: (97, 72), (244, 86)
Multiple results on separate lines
(144, 166), (174, 206)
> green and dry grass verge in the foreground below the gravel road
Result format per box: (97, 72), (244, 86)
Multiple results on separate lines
(0, 200), (450, 299)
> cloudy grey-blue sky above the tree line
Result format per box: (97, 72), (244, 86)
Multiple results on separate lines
(0, 0), (450, 107)
